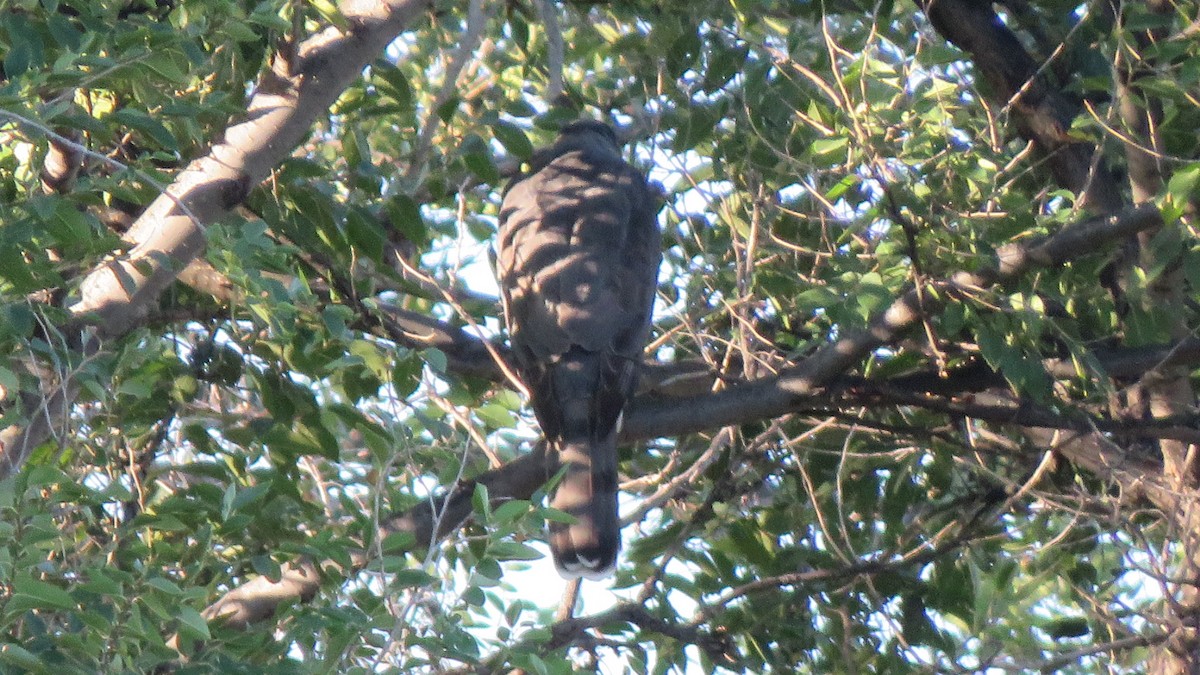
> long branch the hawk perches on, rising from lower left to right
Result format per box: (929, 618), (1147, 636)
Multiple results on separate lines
(196, 200), (1162, 627)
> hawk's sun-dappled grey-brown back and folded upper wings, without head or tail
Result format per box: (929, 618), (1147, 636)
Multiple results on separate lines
(498, 151), (660, 362)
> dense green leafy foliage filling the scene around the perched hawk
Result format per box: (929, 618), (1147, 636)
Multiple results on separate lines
(0, 0), (1200, 673)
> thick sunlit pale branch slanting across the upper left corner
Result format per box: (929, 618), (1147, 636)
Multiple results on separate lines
(0, 0), (428, 477)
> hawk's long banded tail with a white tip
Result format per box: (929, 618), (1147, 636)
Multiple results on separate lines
(548, 429), (620, 579)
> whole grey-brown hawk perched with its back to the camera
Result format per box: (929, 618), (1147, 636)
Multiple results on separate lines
(497, 120), (662, 579)
